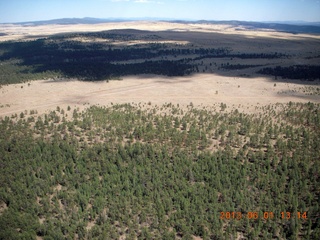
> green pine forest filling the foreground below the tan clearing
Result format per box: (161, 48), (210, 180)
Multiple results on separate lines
(0, 102), (320, 240)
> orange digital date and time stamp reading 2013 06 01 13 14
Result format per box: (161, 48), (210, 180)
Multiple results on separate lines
(220, 212), (308, 220)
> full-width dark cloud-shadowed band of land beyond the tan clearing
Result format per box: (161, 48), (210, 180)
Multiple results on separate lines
(0, 29), (320, 84)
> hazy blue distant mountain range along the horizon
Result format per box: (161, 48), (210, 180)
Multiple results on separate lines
(8, 17), (320, 34)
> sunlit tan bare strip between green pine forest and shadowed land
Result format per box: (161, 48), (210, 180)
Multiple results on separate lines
(0, 74), (320, 117)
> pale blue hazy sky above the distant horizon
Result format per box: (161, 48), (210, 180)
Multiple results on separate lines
(0, 0), (320, 23)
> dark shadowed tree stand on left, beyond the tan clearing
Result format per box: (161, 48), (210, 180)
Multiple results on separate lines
(0, 30), (286, 84)
